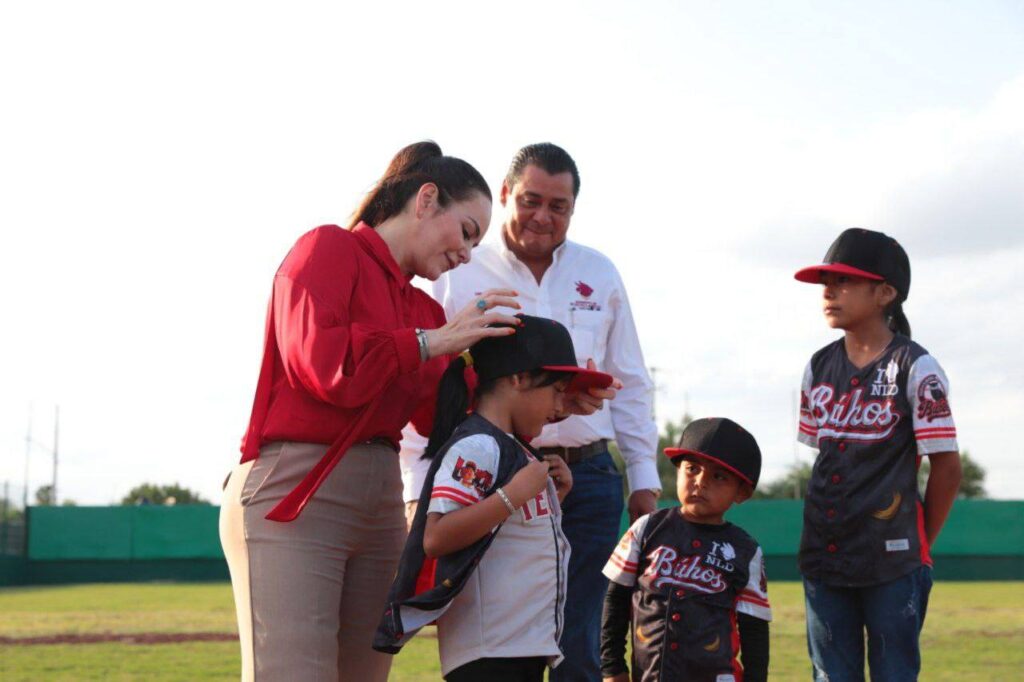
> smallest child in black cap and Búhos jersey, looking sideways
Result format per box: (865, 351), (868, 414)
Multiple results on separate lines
(601, 418), (771, 682)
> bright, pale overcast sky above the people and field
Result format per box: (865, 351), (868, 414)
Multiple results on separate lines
(0, 1), (1024, 504)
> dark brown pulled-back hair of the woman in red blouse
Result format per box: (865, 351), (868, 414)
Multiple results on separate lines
(348, 140), (490, 229)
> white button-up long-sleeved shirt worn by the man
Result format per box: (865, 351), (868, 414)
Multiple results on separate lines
(401, 235), (662, 501)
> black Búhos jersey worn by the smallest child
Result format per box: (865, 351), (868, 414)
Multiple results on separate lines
(604, 507), (771, 682)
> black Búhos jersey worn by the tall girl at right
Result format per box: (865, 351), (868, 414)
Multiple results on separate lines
(799, 334), (958, 587)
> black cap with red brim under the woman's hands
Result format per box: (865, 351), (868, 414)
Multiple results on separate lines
(469, 314), (613, 392)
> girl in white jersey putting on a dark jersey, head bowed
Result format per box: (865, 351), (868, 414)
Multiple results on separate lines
(374, 315), (613, 682)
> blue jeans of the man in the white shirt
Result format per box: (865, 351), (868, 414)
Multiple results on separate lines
(548, 452), (624, 682)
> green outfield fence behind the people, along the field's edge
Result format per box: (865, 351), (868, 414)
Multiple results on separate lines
(0, 500), (1024, 585)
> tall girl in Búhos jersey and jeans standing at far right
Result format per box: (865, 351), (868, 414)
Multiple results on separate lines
(796, 228), (961, 681)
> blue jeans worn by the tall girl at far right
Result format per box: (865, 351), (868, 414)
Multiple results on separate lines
(804, 566), (932, 682)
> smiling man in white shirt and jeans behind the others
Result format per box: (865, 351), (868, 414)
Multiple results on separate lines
(402, 143), (662, 682)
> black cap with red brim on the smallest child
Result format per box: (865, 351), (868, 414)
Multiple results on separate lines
(665, 417), (761, 487)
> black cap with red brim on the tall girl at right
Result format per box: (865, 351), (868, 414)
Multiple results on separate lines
(794, 227), (910, 301)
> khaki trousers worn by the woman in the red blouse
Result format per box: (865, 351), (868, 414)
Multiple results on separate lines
(220, 442), (406, 682)
